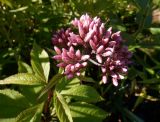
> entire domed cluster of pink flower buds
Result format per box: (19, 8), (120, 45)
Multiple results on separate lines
(52, 14), (132, 86)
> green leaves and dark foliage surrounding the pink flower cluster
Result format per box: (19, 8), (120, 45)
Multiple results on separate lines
(0, 0), (160, 122)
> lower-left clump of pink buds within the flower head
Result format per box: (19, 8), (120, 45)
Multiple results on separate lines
(53, 46), (89, 78)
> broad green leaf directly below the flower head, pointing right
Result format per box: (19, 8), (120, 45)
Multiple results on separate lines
(61, 85), (103, 102)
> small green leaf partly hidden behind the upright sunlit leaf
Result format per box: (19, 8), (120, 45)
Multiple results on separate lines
(18, 61), (33, 73)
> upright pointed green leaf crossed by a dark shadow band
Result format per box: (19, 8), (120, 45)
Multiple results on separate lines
(31, 43), (50, 82)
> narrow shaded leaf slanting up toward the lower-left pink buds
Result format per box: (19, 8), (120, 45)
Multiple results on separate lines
(38, 74), (63, 99)
